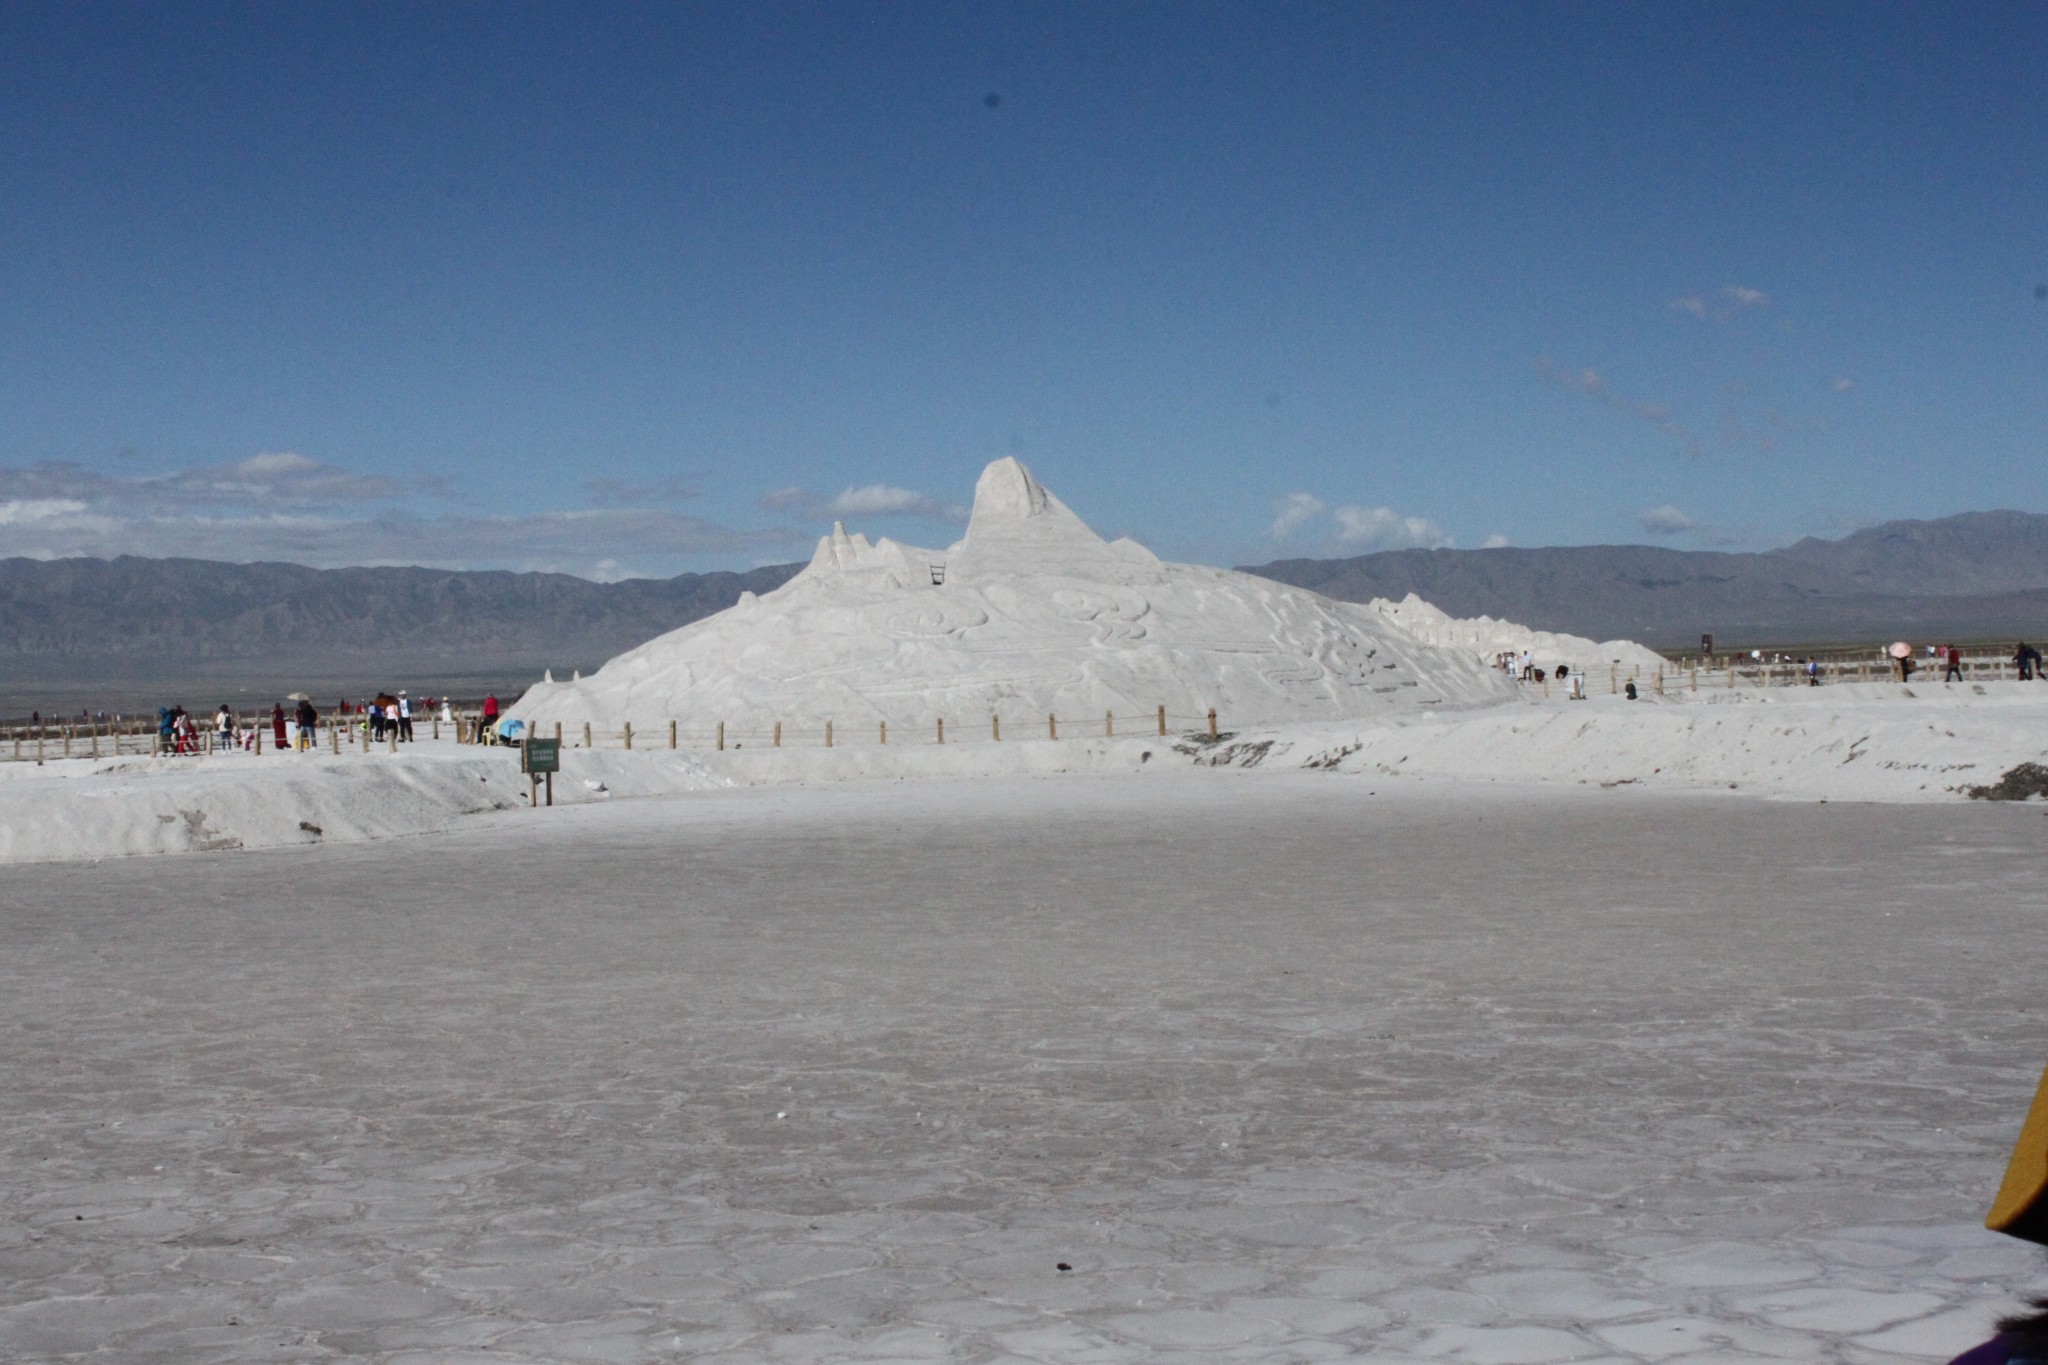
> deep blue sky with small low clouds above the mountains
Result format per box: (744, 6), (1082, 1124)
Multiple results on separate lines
(0, 2), (2048, 577)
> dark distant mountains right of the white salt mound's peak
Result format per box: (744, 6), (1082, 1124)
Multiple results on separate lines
(1245, 512), (2048, 651)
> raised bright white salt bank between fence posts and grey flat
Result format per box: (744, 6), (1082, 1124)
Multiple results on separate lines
(0, 681), (2048, 864)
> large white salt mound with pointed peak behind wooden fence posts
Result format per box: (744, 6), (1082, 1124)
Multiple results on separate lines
(510, 458), (1516, 726)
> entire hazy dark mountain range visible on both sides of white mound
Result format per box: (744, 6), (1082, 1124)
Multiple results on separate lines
(0, 512), (2048, 712)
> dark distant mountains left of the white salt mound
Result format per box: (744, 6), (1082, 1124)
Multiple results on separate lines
(0, 555), (803, 712)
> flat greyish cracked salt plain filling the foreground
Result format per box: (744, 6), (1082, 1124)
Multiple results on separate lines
(0, 769), (2048, 1363)
